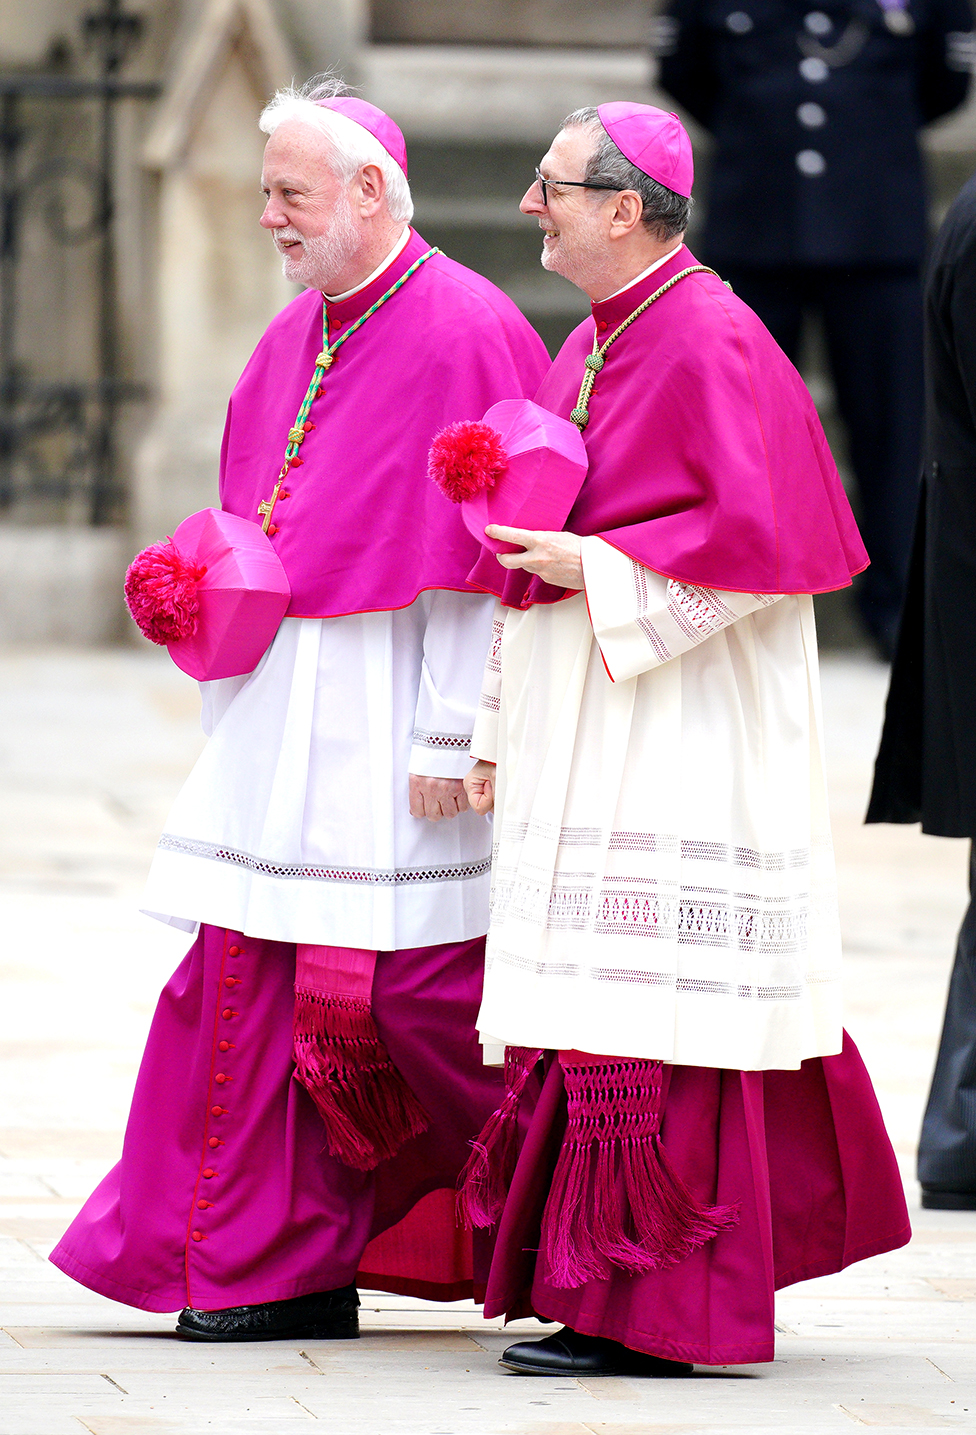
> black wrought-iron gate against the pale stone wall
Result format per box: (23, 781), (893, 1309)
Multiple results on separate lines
(0, 0), (159, 524)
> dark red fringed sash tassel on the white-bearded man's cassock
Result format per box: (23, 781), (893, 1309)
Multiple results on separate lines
(294, 986), (428, 1171)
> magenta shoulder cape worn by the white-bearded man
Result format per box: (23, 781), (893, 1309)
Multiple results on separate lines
(220, 232), (548, 617)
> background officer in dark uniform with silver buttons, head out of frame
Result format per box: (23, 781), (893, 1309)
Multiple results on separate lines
(654, 0), (975, 656)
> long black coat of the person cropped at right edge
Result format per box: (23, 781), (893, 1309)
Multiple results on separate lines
(867, 175), (976, 838)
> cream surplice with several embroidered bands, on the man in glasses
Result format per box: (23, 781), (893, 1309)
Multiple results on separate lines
(472, 538), (841, 1071)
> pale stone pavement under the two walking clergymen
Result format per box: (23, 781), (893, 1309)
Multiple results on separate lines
(0, 650), (976, 1435)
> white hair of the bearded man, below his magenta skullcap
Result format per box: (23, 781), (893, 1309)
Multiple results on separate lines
(258, 73), (413, 224)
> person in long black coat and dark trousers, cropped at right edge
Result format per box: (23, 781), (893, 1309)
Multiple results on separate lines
(867, 175), (976, 1210)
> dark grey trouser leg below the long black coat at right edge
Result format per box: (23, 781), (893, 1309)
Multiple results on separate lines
(919, 855), (976, 1194)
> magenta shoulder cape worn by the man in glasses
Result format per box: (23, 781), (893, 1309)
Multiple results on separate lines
(471, 248), (868, 607)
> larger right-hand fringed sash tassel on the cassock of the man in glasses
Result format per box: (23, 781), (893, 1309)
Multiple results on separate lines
(543, 1060), (739, 1289)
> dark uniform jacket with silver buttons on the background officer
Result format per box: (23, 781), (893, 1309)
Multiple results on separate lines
(654, 0), (973, 265)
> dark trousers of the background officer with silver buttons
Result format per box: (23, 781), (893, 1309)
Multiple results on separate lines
(715, 264), (924, 654)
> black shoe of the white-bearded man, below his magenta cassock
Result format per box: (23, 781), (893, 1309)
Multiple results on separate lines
(177, 1286), (359, 1340)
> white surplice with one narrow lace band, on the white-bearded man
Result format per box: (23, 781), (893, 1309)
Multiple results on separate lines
(142, 590), (492, 951)
